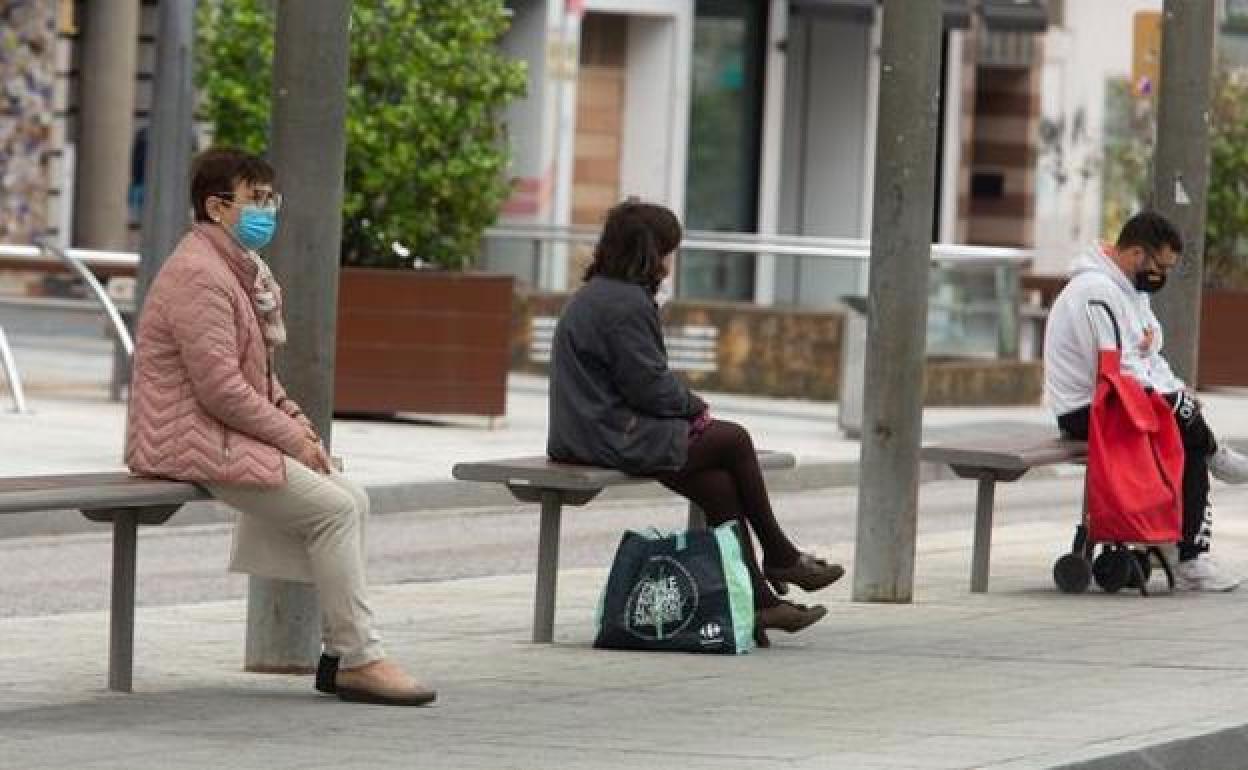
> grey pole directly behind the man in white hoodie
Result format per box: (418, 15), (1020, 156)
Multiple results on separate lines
(1153, 0), (1214, 387)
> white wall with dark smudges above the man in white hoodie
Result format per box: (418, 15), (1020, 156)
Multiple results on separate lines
(1036, 0), (1162, 273)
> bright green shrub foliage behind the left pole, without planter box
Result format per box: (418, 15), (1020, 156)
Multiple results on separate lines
(196, 0), (527, 268)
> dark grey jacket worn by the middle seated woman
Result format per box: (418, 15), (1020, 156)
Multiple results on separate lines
(547, 276), (706, 475)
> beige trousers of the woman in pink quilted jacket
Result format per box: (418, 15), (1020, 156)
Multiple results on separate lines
(205, 457), (383, 668)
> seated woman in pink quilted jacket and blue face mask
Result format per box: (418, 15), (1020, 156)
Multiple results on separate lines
(126, 149), (436, 705)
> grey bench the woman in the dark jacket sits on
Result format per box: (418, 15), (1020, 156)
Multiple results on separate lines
(451, 451), (797, 643)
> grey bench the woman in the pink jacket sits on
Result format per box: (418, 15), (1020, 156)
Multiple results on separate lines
(0, 473), (212, 693)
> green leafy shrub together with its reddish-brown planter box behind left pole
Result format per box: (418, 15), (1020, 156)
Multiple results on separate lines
(196, 0), (527, 416)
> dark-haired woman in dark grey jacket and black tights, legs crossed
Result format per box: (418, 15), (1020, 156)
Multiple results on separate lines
(547, 201), (845, 646)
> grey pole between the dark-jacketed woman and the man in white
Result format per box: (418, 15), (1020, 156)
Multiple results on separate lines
(854, 0), (941, 602)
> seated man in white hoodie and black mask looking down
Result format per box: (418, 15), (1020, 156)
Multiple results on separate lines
(1045, 211), (1248, 592)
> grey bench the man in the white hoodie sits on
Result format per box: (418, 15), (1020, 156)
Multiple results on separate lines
(920, 429), (1088, 593)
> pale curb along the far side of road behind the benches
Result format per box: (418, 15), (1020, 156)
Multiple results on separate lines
(0, 461), (1061, 539)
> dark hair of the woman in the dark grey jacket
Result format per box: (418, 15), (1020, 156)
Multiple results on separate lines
(585, 200), (681, 295)
